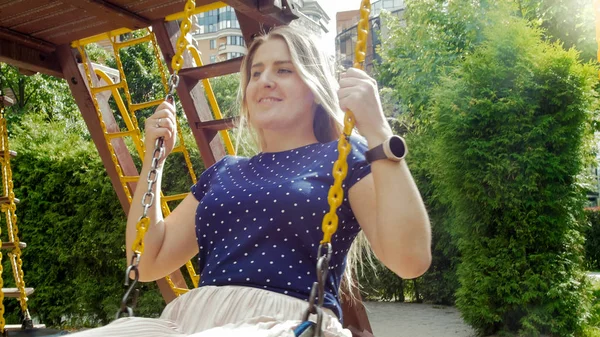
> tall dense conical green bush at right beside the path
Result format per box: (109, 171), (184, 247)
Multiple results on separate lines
(432, 13), (595, 336)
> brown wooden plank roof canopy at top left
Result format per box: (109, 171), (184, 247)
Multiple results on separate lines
(0, 0), (297, 77)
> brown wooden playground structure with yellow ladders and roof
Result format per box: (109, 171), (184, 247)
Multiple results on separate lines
(0, 0), (371, 336)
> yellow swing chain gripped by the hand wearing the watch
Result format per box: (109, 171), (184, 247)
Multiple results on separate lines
(303, 0), (371, 337)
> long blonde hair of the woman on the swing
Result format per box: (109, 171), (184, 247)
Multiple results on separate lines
(236, 26), (371, 300)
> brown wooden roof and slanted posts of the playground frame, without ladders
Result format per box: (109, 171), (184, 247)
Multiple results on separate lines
(0, 0), (372, 336)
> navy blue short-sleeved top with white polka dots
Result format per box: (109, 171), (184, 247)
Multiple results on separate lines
(191, 136), (371, 319)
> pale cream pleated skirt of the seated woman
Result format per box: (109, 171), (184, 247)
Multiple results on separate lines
(69, 286), (352, 337)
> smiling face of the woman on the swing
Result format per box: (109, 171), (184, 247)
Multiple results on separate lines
(246, 38), (315, 132)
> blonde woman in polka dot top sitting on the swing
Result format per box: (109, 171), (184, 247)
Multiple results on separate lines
(71, 27), (431, 337)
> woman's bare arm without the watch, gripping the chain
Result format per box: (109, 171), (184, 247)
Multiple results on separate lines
(126, 102), (198, 281)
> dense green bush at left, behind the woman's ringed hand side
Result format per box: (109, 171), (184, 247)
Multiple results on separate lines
(3, 116), (175, 327)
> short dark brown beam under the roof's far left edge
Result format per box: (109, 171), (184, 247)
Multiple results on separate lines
(0, 34), (63, 77)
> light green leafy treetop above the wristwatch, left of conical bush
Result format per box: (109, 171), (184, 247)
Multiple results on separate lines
(377, 0), (488, 118)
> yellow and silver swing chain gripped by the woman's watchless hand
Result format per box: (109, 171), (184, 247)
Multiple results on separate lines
(117, 0), (196, 318)
